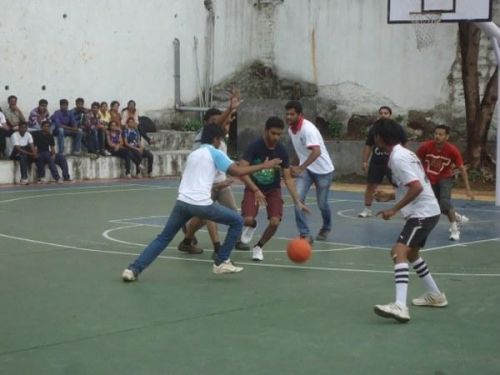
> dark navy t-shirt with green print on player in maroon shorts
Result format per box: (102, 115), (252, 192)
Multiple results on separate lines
(243, 138), (290, 192)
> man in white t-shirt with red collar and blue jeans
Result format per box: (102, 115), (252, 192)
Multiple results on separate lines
(285, 100), (335, 243)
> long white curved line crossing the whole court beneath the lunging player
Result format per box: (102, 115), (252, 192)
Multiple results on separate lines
(0, 233), (500, 277)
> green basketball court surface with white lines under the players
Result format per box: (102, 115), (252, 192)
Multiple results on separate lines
(0, 180), (500, 375)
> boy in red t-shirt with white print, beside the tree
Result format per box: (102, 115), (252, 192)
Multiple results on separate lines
(416, 125), (474, 241)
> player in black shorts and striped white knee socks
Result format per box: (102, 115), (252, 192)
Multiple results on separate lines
(373, 119), (448, 323)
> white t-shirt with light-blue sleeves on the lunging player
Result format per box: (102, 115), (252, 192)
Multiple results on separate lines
(177, 144), (233, 206)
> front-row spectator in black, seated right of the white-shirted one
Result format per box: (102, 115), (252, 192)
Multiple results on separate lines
(33, 121), (71, 183)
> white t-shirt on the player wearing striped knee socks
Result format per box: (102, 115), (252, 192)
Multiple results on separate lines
(389, 145), (441, 219)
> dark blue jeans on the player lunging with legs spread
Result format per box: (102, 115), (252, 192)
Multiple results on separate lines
(128, 200), (243, 274)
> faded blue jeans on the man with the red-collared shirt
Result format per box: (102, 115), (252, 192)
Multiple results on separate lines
(295, 169), (335, 236)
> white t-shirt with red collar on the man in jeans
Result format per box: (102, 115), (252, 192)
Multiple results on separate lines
(288, 119), (335, 174)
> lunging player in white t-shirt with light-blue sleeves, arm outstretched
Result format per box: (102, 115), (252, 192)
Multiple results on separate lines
(122, 125), (281, 281)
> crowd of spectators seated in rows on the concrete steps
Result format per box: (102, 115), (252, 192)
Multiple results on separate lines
(0, 95), (154, 184)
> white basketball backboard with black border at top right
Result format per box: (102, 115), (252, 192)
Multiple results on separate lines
(387, 0), (493, 23)
